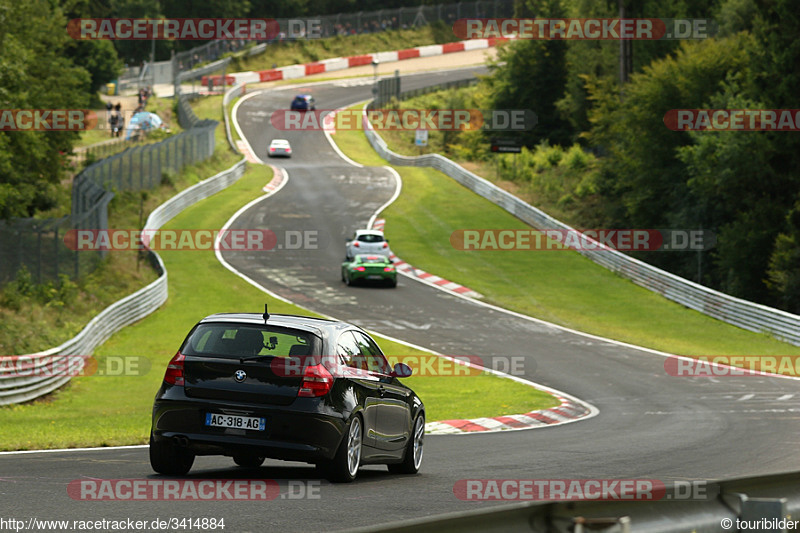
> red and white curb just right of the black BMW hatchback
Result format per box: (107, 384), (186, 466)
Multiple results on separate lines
(425, 396), (592, 435)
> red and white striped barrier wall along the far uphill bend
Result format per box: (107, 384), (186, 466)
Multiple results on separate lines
(202, 37), (509, 87)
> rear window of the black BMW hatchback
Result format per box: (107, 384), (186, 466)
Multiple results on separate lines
(181, 324), (317, 359)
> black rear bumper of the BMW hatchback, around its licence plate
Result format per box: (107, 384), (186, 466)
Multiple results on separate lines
(153, 398), (346, 462)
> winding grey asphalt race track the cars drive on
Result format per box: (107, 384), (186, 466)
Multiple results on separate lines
(0, 69), (800, 532)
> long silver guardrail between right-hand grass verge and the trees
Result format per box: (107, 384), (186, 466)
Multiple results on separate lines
(364, 97), (800, 345)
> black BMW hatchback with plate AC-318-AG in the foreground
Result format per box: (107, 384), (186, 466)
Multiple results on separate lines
(150, 306), (425, 482)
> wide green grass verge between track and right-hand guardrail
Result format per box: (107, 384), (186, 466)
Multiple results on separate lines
(333, 102), (800, 355)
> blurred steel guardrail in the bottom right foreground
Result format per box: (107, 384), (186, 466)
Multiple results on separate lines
(353, 472), (800, 533)
